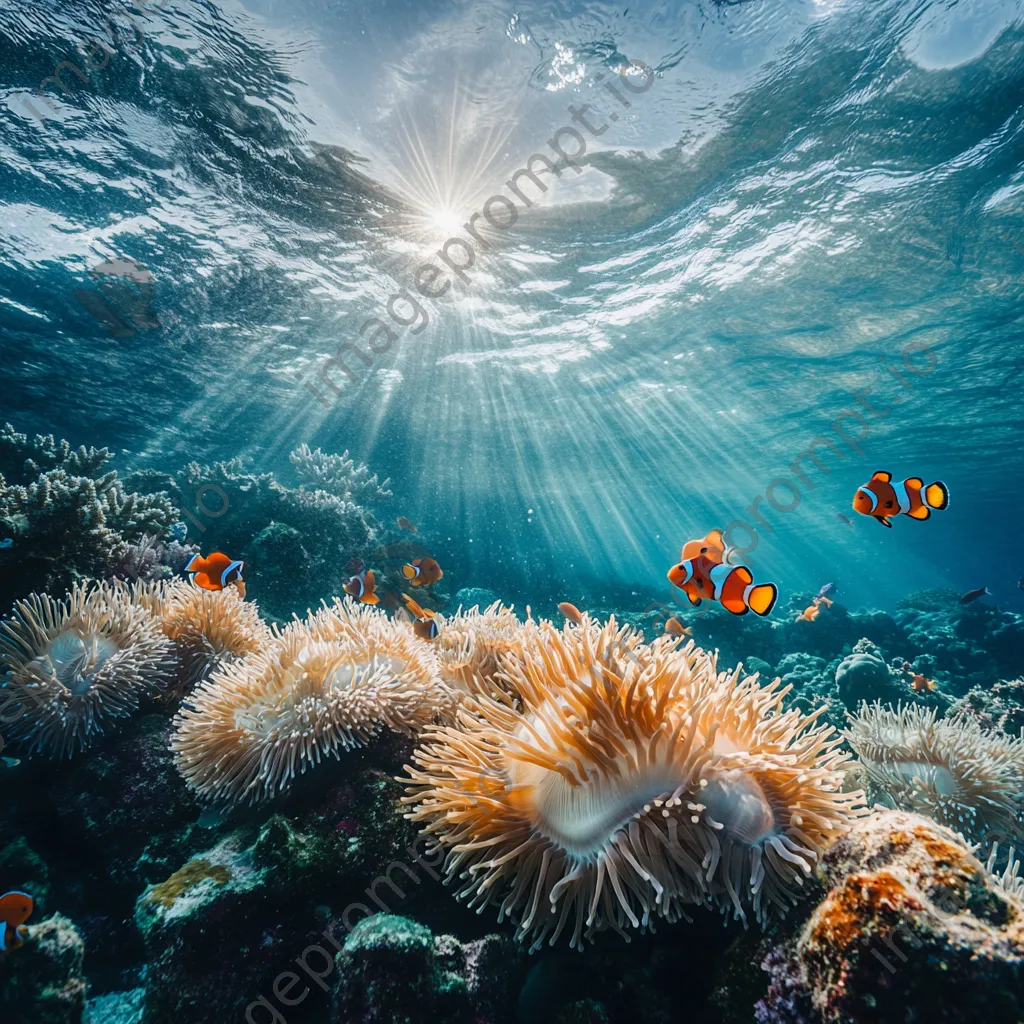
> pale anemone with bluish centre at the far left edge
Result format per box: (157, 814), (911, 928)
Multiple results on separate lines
(0, 584), (175, 758)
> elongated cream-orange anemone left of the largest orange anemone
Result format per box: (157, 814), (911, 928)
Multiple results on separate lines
(171, 600), (458, 804)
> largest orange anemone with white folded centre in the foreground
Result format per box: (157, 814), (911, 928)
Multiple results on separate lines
(403, 616), (862, 949)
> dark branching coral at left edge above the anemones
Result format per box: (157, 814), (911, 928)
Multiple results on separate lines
(0, 424), (179, 611)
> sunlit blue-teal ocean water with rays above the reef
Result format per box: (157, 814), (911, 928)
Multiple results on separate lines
(0, 0), (1024, 609)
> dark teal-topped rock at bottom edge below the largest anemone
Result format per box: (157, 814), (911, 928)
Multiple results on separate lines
(330, 913), (527, 1024)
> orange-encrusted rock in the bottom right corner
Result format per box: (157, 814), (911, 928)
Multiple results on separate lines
(755, 811), (1024, 1024)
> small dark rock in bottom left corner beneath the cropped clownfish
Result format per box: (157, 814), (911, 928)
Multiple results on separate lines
(0, 913), (86, 1024)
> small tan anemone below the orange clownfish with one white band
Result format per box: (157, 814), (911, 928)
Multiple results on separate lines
(133, 581), (271, 692)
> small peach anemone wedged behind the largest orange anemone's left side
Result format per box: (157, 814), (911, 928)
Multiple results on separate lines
(434, 601), (536, 703)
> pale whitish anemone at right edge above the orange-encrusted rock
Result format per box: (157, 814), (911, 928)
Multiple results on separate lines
(847, 705), (1024, 841)
